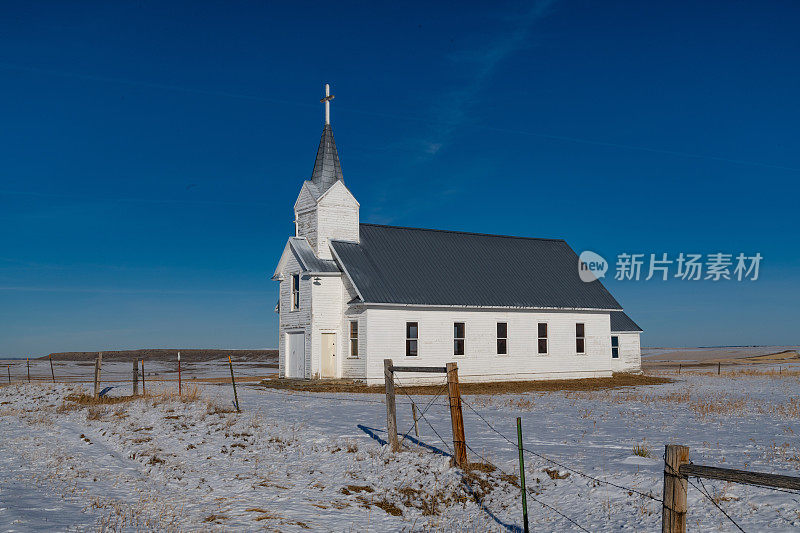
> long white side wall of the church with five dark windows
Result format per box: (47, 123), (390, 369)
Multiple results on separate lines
(366, 308), (612, 385)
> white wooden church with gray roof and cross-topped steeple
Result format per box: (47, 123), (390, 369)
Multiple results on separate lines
(273, 85), (642, 385)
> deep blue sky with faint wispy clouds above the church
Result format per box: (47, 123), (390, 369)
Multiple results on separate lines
(0, 1), (800, 356)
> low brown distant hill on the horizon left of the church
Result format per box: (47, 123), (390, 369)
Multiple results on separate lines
(39, 348), (278, 361)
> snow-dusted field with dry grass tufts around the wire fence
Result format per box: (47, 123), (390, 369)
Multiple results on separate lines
(0, 367), (800, 531)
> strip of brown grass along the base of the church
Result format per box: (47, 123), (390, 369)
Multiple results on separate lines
(261, 374), (674, 394)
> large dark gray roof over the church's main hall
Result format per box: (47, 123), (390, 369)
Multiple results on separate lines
(331, 224), (622, 309)
